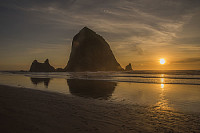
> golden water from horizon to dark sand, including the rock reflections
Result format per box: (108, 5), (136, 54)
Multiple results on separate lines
(0, 70), (200, 113)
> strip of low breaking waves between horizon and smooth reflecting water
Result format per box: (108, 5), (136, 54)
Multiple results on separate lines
(1, 72), (200, 85)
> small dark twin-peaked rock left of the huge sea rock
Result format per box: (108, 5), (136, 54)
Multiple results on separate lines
(29, 59), (55, 72)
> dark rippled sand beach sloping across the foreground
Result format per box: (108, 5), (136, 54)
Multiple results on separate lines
(0, 85), (200, 133)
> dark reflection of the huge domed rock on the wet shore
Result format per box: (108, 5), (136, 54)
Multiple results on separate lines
(67, 79), (117, 99)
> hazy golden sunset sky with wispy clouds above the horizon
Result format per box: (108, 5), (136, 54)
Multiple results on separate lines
(0, 0), (200, 70)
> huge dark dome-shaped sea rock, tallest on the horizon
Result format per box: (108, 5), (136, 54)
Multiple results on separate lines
(65, 27), (123, 72)
